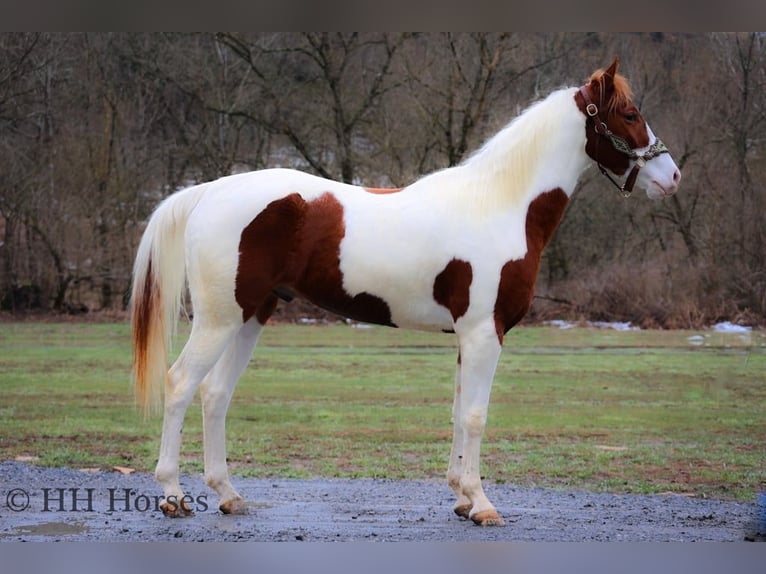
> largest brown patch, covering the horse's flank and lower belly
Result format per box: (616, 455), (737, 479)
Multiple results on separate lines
(234, 193), (395, 326)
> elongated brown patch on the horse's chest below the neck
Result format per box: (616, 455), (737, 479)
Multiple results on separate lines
(495, 188), (569, 343)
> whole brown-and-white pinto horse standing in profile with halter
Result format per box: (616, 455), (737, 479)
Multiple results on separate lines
(131, 58), (681, 526)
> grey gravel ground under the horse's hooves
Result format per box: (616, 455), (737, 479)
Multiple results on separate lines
(0, 462), (764, 542)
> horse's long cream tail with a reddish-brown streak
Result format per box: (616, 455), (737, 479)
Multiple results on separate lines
(131, 186), (205, 415)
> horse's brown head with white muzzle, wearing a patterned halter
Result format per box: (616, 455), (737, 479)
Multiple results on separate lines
(575, 58), (681, 198)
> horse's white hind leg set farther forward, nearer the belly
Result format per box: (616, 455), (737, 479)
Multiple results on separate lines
(200, 318), (263, 514)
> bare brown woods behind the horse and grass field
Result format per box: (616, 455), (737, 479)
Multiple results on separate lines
(0, 33), (766, 327)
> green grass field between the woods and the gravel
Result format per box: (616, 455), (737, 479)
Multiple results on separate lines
(0, 323), (766, 500)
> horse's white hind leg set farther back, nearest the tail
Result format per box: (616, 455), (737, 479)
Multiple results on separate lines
(155, 319), (238, 517)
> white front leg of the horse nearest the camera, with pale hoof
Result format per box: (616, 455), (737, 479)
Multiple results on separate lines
(450, 321), (505, 526)
